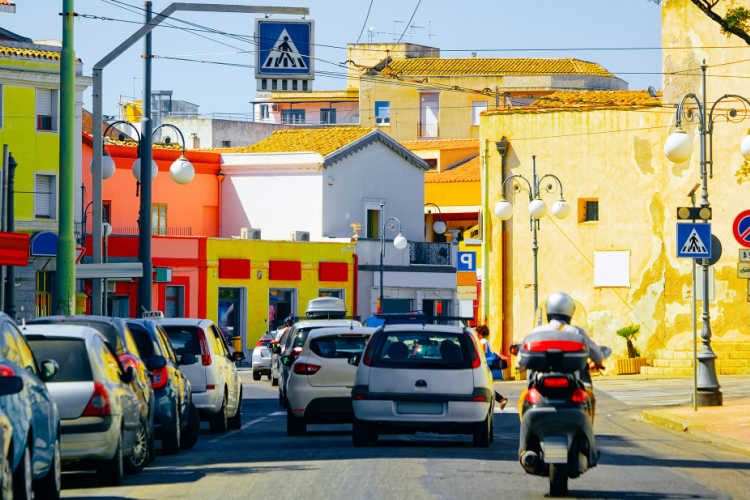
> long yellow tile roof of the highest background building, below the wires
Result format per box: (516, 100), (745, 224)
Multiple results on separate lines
(383, 57), (613, 76)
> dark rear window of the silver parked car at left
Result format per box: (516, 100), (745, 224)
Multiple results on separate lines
(28, 338), (94, 382)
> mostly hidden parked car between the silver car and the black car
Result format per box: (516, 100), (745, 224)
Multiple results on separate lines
(27, 316), (155, 472)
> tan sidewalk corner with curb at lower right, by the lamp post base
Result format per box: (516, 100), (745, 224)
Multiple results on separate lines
(640, 398), (750, 455)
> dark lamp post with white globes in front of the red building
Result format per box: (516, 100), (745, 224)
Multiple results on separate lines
(92, 120), (195, 315)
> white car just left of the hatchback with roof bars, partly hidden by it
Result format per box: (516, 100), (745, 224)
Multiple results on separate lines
(286, 326), (375, 436)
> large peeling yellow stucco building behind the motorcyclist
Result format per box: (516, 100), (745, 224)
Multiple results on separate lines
(481, 0), (750, 375)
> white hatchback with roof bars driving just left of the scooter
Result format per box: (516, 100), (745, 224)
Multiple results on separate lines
(352, 324), (497, 447)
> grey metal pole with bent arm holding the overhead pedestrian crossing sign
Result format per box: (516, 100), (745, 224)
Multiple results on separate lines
(89, 0), (310, 314)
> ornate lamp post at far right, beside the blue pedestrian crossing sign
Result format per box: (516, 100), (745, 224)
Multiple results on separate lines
(664, 61), (750, 406)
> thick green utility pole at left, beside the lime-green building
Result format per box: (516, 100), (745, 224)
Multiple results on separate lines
(55, 0), (76, 315)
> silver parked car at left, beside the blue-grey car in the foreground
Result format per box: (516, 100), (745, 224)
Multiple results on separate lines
(24, 324), (147, 485)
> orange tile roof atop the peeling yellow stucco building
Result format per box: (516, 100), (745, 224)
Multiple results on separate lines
(482, 90), (662, 115)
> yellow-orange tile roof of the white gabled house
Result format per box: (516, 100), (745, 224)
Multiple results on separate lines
(213, 127), (374, 156)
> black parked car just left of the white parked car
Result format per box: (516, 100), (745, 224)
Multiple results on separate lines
(126, 319), (200, 453)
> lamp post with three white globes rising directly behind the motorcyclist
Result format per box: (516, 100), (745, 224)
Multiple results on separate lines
(495, 155), (570, 324)
